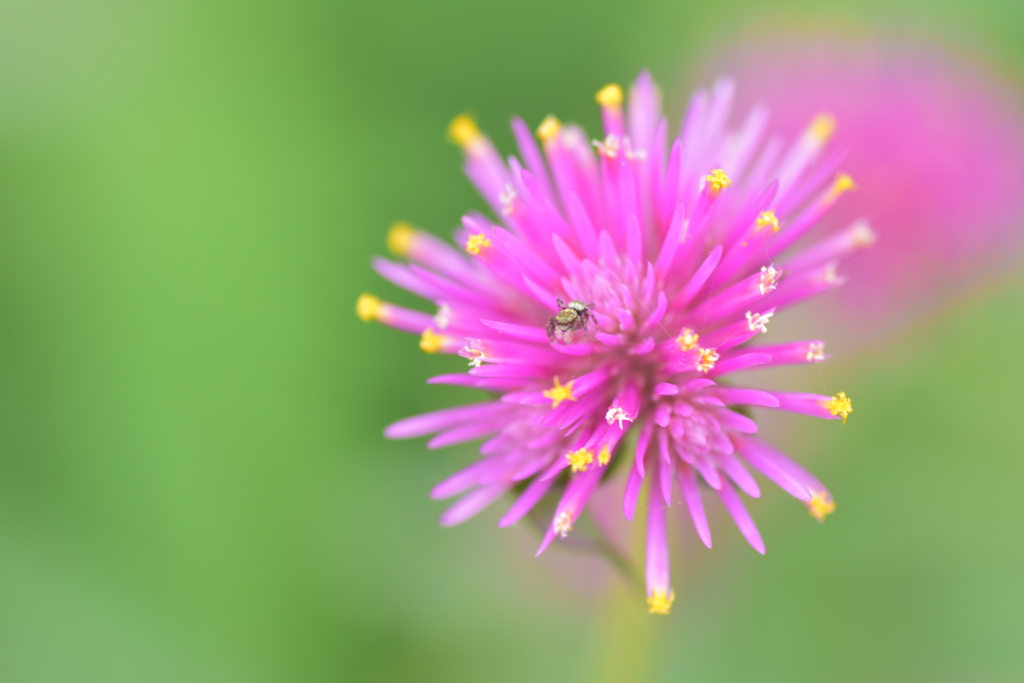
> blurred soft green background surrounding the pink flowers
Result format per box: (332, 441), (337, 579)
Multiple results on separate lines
(0, 0), (1024, 682)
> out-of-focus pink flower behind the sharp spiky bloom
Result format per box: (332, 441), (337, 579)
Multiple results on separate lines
(714, 36), (1024, 336)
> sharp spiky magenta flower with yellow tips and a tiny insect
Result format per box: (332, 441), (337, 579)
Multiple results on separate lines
(356, 73), (870, 613)
